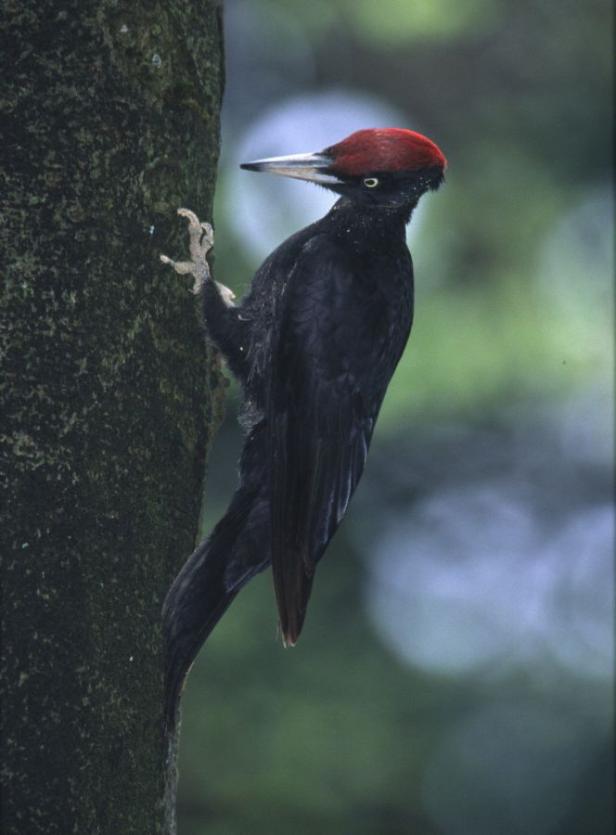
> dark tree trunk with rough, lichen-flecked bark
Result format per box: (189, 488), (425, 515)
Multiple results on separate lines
(0, 0), (223, 835)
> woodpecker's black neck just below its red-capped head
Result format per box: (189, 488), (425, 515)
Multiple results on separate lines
(323, 197), (417, 248)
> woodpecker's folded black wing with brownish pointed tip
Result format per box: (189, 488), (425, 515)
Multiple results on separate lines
(267, 242), (382, 645)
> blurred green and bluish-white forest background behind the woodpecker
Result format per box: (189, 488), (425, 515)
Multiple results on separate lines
(179, 0), (614, 835)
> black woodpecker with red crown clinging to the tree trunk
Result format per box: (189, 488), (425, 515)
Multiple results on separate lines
(161, 128), (447, 725)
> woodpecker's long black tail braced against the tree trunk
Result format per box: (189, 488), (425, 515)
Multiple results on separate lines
(163, 488), (270, 730)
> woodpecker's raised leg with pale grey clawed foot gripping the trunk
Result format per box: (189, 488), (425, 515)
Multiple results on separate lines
(160, 209), (250, 383)
